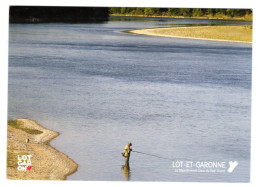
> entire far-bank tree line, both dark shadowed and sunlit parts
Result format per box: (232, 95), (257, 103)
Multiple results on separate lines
(9, 6), (252, 23)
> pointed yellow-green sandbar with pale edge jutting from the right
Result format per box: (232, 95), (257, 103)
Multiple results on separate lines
(127, 25), (252, 43)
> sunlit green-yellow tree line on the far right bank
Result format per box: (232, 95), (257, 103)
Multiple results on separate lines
(109, 7), (252, 17)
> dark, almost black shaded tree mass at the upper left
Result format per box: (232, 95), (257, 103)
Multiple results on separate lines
(9, 6), (109, 23)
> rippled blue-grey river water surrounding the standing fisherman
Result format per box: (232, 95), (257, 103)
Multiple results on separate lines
(8, 17), (252, 182)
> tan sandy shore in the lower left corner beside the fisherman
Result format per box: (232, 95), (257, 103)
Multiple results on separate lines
(7, 119), (78, 180)
